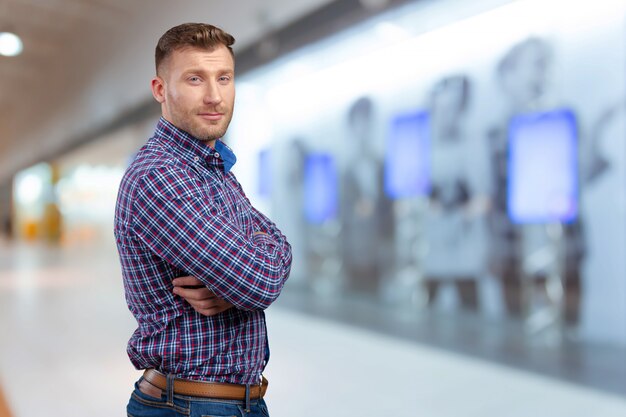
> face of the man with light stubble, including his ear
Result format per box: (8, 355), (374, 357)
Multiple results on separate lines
(152, 45), (235, 145)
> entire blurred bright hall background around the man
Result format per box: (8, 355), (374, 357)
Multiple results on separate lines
(0, 0), (626, 417)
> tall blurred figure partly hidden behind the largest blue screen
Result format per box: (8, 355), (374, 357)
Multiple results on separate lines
(488, 37), (585, 325)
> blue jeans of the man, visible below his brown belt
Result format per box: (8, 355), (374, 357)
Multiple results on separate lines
(126, 379), (269, 417)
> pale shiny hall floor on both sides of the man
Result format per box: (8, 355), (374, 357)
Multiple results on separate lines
(0, 239), (626, 417)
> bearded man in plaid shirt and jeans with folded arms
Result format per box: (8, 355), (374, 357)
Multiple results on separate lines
(115, 23), (291, 417)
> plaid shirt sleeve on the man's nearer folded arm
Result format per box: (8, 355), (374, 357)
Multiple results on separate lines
(134, 167), (291, 310)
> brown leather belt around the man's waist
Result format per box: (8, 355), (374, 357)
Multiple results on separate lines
(143, 369), (268, 401)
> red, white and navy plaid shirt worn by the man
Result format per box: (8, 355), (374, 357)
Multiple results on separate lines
(115, 118), (291, 384)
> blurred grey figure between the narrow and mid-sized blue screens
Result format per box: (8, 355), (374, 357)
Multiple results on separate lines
(340, 97), (393, 295)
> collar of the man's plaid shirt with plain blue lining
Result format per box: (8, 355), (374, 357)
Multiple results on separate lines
(155, 117), (237, 173)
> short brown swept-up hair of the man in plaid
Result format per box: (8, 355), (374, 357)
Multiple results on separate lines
(154, 23), (235, 74)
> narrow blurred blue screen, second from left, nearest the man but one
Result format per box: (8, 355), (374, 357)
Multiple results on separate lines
(304, 153), (339, 224)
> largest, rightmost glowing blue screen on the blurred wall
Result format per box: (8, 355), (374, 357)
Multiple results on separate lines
(507, 109), (578, 223)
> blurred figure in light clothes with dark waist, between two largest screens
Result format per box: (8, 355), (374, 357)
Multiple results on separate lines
(423, 75), (485, 310)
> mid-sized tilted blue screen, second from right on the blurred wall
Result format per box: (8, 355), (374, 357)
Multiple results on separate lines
(385, 111), (430, 199)
